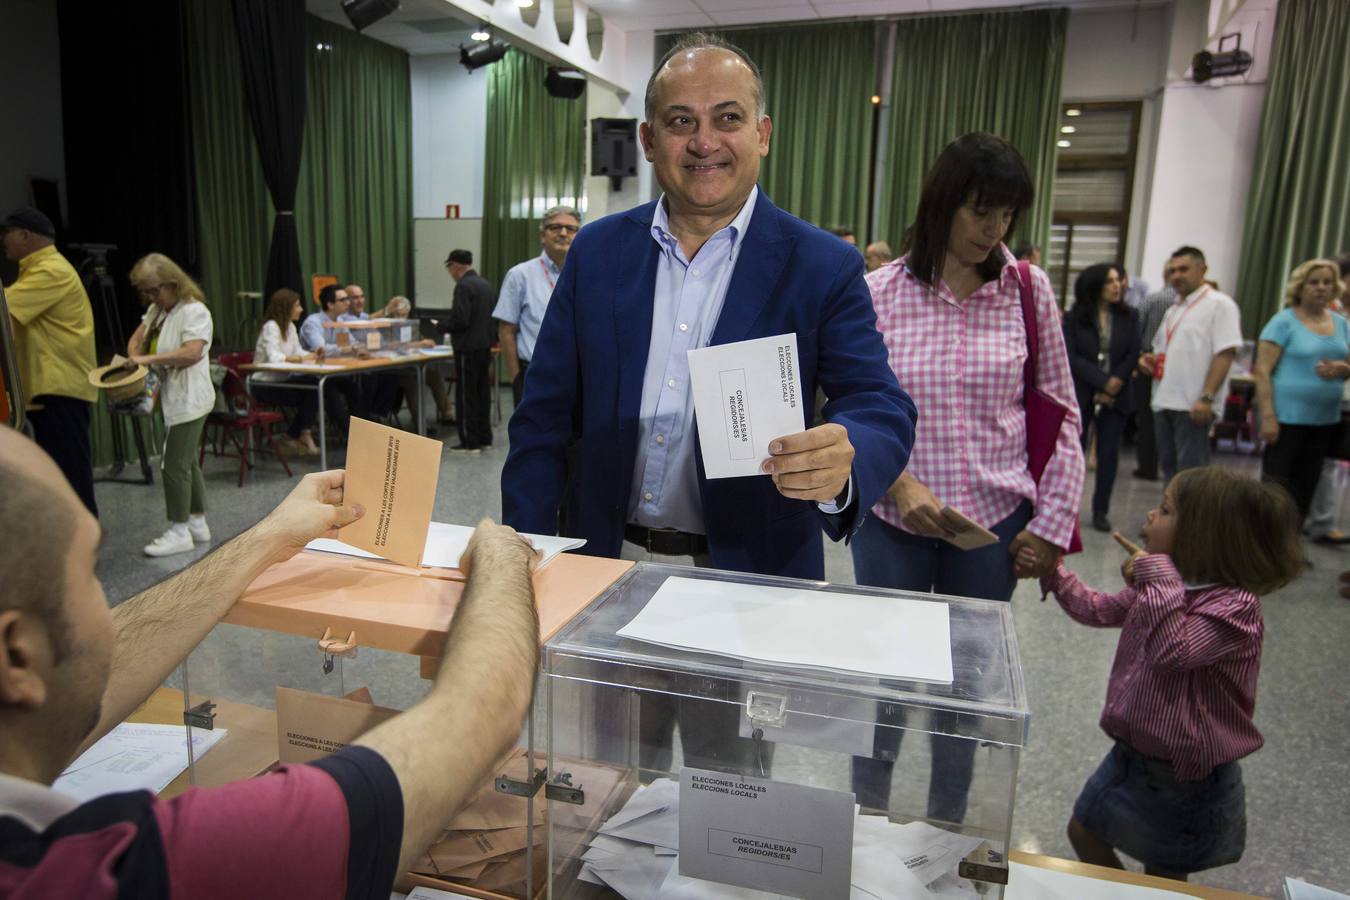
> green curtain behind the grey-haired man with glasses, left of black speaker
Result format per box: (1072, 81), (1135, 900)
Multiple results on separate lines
(488, 49), (586, 285)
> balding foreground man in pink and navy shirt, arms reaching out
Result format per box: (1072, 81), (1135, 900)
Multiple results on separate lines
(0, 426), (539, 900)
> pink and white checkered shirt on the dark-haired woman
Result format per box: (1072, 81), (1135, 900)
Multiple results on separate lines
(867, 253), (1084, 546)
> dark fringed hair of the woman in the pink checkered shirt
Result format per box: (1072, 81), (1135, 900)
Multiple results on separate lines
(903, 134), (1035, 285)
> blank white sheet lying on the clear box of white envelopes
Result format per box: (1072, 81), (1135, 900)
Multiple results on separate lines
(618, 578), (952, 684)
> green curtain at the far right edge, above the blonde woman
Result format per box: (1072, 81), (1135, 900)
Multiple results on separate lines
(1237, 0), (1350, 336)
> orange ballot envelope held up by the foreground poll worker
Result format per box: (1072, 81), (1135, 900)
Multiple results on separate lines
(338, 417), (441, 568)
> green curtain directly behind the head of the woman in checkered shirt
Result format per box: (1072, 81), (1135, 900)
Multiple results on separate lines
(876, 8), (1069, 256)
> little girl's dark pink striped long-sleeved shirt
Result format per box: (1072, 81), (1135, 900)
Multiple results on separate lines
(1041, 553), (1265, 781)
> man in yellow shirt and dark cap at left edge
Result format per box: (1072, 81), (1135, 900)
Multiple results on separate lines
(0, 206), (99, 515)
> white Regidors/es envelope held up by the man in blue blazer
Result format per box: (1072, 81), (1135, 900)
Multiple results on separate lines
(689, 335), (815, 478)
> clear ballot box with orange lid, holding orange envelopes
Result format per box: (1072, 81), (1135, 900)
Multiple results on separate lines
(164, 551), (630, 900)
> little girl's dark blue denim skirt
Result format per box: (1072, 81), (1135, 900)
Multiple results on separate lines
(1073, 741), (1247, 874)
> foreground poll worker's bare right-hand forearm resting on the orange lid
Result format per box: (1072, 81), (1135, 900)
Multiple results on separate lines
(355, 519), (539, 872)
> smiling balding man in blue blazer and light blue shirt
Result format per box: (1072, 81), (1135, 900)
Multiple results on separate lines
(502, 35), (915, 579)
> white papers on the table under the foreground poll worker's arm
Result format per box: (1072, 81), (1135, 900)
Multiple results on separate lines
(51, 722), (228, 801)
